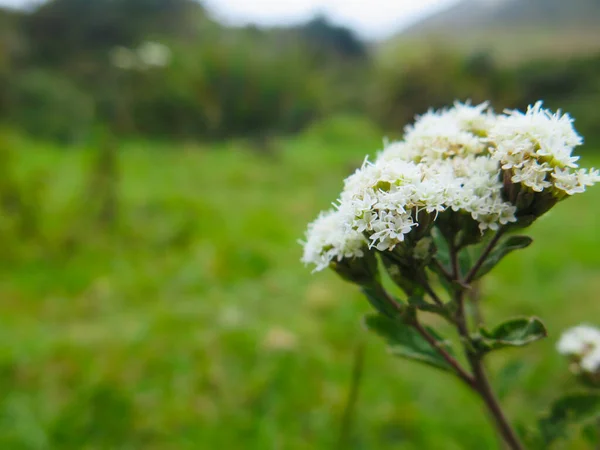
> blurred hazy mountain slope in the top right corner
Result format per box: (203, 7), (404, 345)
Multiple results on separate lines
(392, 0), (600, 59)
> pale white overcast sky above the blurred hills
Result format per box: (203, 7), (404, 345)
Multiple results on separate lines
(0, 0), (458, 39)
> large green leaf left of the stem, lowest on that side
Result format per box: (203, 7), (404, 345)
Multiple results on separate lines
(364, 314), (452, 371)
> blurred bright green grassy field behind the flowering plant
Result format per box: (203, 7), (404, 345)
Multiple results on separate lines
(0, 118), (600, 450)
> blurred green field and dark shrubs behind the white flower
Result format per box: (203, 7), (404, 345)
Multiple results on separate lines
(0, 0), (600, 450)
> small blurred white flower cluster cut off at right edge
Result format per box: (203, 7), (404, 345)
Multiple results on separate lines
(556, 325), (600, 374)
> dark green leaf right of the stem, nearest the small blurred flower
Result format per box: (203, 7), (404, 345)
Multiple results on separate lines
(478, 317), (548, 352)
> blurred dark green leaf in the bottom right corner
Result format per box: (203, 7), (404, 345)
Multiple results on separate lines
(539, 392), (600, 446)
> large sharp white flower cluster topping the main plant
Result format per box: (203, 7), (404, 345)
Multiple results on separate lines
(302, 103), (600, 270)
